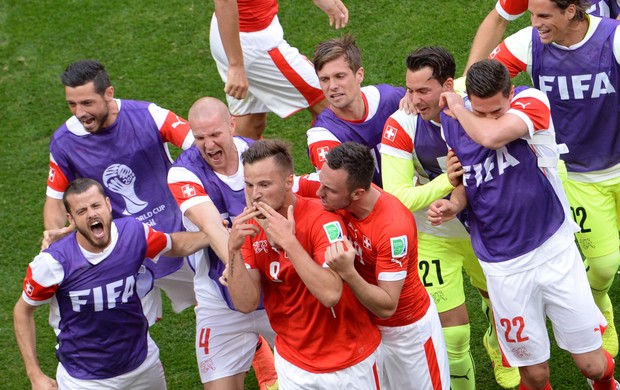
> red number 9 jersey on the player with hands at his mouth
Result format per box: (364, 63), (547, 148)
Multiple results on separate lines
(242, 196), (381, 373)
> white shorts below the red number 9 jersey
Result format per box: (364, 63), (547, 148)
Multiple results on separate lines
(273, 348), (381, 390)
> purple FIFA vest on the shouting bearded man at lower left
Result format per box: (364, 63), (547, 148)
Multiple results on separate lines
(46, 218), (149, 379)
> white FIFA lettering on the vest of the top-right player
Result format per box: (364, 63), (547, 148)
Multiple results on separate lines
(538, 72), (616, 100)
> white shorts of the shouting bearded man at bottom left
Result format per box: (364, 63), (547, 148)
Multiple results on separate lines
(56, 335), (167, 390)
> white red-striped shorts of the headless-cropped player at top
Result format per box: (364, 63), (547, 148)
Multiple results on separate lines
(209, 14), (325, 118)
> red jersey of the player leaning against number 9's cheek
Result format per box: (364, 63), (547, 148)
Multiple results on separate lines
(342, 190), (430, 326)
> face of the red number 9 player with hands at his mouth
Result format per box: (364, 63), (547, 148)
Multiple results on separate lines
(243, 157), (293, 215)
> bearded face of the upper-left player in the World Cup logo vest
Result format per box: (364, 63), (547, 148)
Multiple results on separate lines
(65, 81), (114, 133)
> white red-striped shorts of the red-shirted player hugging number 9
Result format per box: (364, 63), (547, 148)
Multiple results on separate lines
(378, 299), (450, 390)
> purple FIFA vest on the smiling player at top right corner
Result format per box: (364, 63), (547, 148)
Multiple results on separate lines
(532, 18), (620, 172)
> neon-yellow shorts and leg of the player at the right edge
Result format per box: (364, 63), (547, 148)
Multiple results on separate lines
(563, 178), (620, 356)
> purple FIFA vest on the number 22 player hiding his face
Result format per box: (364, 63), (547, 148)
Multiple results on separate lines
(441, 113), (564, 262)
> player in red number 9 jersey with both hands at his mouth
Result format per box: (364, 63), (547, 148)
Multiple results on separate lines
(228, 141), (381, 390)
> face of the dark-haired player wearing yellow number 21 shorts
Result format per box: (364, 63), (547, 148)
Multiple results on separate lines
(406, 67), (452, 121)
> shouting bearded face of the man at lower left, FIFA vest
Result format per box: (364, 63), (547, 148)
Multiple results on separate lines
(67, 186), (112, 252)
